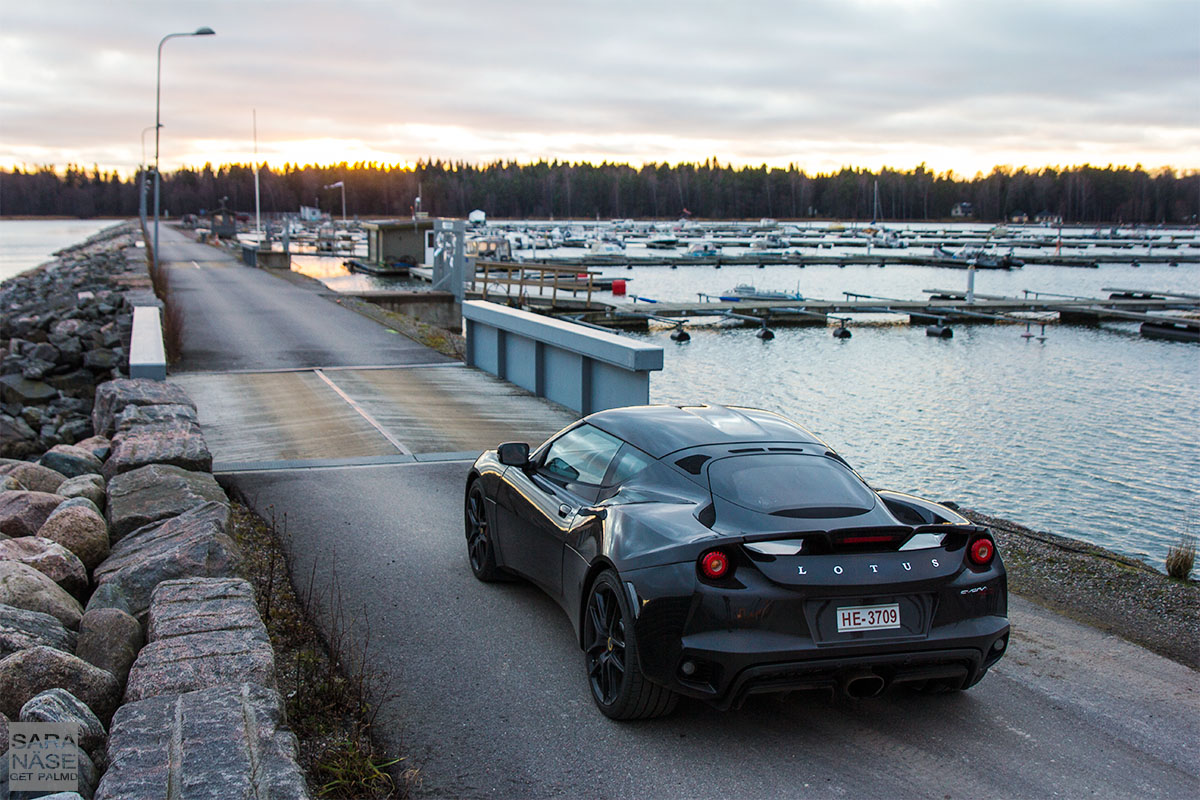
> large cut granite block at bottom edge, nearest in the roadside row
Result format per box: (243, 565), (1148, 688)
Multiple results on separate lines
(96, 684), (308, 800)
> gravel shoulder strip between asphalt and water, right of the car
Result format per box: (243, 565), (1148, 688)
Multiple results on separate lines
(959, 509), (1200, 669)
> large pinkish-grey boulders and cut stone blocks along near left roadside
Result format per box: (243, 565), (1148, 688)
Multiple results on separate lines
(0, 379), (308, 800)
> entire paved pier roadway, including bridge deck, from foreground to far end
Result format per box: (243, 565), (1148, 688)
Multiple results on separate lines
(152, 229), (1200, 799)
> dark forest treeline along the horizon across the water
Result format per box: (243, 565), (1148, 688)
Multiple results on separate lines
(0, 160), (1200, 224)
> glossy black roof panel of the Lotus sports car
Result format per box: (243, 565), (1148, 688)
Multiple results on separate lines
(586, 405), (824, 458)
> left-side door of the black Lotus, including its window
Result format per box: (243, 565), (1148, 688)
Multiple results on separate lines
(503, 425), (623, 597)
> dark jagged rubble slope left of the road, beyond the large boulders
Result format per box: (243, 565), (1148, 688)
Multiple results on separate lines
(0, 223), (152, 458)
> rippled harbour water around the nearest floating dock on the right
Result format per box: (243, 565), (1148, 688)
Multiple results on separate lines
(606, 265), (1200, 569)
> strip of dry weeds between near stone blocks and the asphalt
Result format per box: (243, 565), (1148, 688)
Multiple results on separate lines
(232, 504), (419, 800)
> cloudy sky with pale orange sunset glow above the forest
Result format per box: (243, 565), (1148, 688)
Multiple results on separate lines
(0, 0), (1200, 176)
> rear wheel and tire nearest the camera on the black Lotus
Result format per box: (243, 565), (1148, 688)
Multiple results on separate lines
(583, 570), (679, 720)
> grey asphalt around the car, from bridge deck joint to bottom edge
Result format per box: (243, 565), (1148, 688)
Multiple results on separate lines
(228, 462), (1200, 799)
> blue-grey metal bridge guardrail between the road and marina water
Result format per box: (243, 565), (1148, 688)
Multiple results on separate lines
(462, 300), (662, 415)
